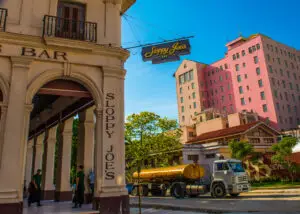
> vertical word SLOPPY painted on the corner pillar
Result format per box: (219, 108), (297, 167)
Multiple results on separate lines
(105, 93), (116, 138)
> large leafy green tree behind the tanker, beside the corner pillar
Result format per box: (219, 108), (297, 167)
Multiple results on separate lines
(125, 112), (181, 180)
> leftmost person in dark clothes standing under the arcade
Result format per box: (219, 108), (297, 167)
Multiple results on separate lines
(28, 169), (42, 207)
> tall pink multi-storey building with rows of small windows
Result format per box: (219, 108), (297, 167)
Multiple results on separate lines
(175, 34), (300, 130)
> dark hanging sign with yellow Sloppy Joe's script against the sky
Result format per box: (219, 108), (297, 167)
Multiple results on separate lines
(142, 40), (191, 64)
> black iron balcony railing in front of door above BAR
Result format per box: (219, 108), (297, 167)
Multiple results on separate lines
(43, 15), (97, 42)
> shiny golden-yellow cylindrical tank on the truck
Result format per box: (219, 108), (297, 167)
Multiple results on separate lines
(133, 164), (204, 182)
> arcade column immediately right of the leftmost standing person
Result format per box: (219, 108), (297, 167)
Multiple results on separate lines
(43, 126), (57, 200)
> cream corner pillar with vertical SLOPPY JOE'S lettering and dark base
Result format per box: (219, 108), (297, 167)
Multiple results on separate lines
(94, 67), (130, 214)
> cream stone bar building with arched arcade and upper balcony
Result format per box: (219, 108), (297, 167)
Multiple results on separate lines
(0, 0), (135, 214)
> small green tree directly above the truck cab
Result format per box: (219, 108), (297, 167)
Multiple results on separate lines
(229, 140), (254, 161)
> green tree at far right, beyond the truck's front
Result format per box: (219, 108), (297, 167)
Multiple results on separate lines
(272, 137), (298, 182)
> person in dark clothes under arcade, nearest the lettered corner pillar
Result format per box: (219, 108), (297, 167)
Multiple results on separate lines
(73, 165), (84, 208)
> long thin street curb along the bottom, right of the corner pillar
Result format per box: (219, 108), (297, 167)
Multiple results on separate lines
(130, 203), (259, 214)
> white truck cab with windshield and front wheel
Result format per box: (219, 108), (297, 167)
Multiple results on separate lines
(210, 159), (250, 198)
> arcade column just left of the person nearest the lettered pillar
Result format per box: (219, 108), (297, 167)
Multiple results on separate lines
(55, 117), (73, 201)
